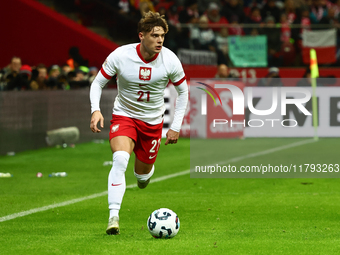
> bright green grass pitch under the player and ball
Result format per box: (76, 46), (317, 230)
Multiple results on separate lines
(0, 138), (340, 255)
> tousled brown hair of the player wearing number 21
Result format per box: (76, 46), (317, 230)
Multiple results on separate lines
(137, 11), (169, 33)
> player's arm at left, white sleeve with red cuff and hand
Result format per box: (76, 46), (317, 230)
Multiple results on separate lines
(90, 52), (119, 133)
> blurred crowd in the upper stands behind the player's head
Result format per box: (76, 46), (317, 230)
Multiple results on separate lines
(73, 0), (340, 67)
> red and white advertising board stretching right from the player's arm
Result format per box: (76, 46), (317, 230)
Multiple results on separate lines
(173, 79), (340, 138)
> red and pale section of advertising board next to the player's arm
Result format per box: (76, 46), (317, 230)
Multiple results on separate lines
(172, 79), (244, 138)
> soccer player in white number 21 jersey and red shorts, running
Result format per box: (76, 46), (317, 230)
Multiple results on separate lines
(90, 11), (188, 235)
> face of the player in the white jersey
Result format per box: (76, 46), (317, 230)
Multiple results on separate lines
(139, 26), (165, 56)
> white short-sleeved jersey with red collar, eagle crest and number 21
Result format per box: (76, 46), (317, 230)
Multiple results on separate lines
(101, 43), (185, 125)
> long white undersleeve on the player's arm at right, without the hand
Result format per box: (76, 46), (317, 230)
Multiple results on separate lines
(170, 80), (189, 132)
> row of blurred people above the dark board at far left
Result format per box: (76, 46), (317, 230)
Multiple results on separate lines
(0, 47), (98, 91)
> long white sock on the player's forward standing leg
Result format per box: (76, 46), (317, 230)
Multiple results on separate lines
(108, 151), (130, 218)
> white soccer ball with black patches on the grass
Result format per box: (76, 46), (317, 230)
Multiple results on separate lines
(147, 208), (180, 238)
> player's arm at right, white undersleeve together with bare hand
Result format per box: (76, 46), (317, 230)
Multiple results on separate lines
(165, 80), (188, 145)
